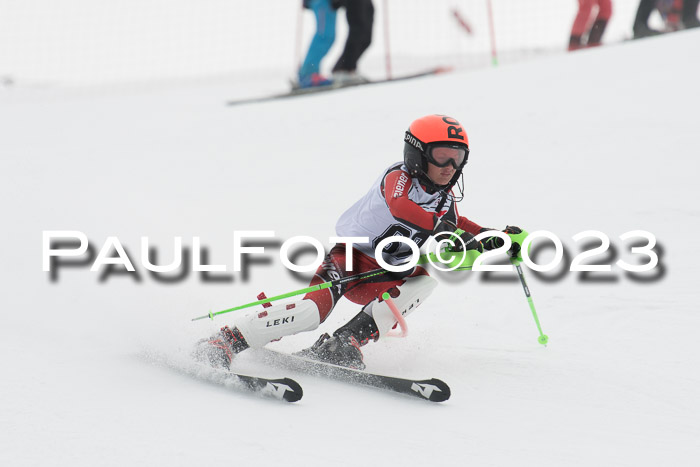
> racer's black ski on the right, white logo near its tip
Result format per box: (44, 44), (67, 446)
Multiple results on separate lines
(259, 349), (450, 402)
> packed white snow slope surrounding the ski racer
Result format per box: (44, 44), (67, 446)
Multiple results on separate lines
(0, 31), (700, 466)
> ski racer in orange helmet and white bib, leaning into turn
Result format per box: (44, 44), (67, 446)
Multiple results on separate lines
(195, 115), (520, 369)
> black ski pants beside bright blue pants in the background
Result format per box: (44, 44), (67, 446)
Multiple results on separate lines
(333, 0), (374, 72)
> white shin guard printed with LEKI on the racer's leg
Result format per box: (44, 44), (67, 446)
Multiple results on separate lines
(235, 300), (321, 348)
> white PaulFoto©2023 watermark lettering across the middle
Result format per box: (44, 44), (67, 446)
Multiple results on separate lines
(42, 230), (660, 279)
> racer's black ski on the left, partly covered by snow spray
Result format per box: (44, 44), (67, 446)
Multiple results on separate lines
(143, 352), (304, 402)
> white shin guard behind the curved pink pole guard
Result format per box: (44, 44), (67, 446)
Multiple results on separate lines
(365, 276), (437, 337)
